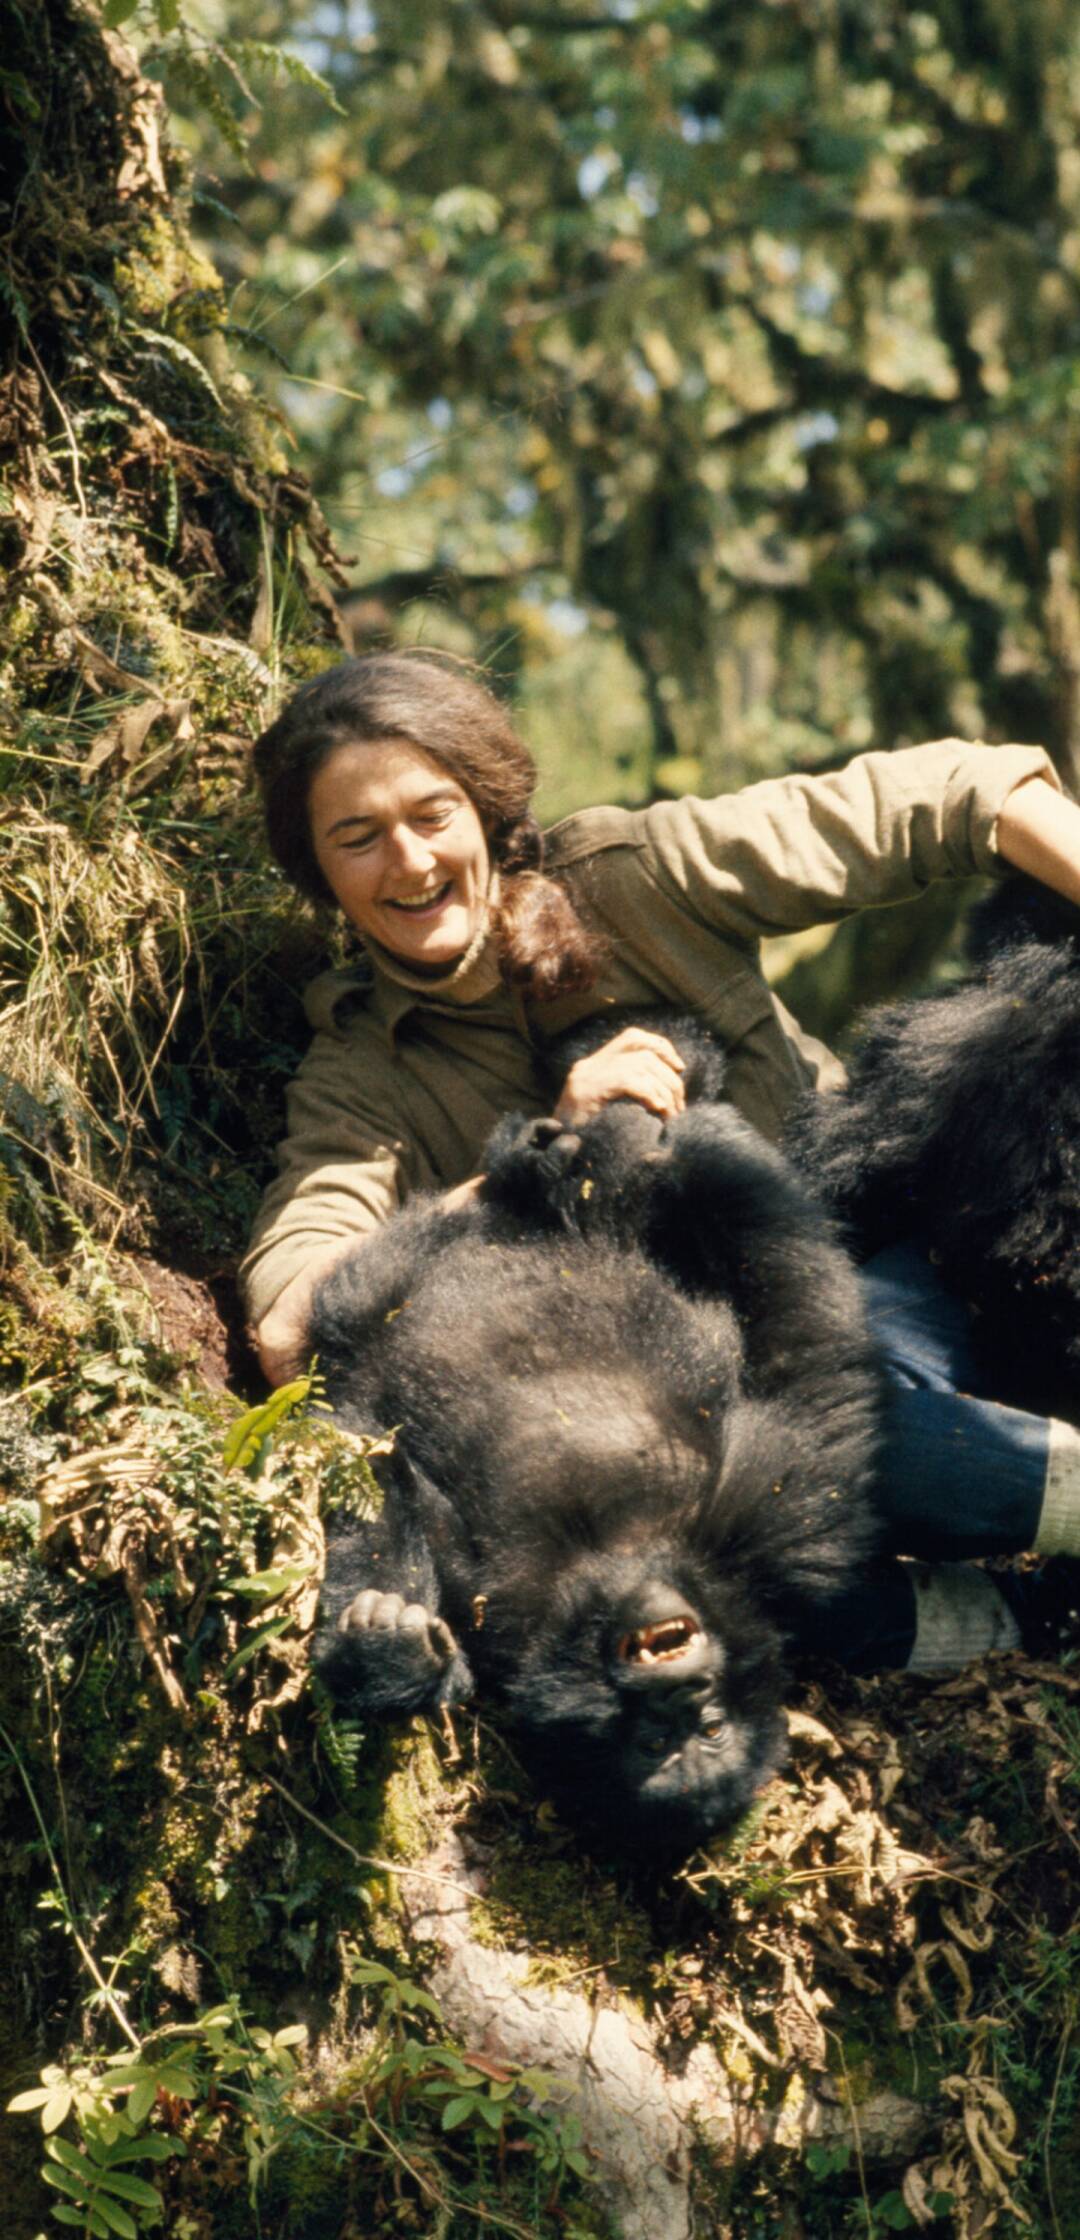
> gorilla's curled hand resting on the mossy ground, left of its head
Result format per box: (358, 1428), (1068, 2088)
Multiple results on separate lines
(320, 1586), (473, 1711)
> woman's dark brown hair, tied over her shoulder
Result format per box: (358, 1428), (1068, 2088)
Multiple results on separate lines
(255, 654), (607, 1004)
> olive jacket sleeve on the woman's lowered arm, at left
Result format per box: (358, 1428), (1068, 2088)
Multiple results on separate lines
(240, 1035), (408, 1324)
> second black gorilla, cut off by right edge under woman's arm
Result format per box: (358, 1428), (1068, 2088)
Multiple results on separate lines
(791, 878), (1080, 1420)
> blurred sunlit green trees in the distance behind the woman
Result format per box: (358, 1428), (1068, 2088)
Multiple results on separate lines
(162, 0), (1080, 815)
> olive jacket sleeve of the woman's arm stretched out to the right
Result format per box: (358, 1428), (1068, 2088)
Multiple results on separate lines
(643, 739), (1058, 941)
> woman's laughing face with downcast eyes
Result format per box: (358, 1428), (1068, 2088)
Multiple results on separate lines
(307, 739), (491, 972)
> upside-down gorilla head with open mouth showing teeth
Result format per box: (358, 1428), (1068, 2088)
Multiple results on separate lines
(497, 1557), (784, 1852)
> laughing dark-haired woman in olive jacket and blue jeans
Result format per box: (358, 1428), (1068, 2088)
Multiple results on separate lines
(244, 654), (1080, 1664)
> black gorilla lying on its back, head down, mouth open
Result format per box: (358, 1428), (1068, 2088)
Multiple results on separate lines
(311, 1015), (878, 1852)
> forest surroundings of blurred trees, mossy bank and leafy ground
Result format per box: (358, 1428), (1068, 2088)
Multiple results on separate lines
(0, 0), (1080, 2240)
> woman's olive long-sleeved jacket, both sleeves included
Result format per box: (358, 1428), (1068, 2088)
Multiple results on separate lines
(242, 739), (1055, 1324)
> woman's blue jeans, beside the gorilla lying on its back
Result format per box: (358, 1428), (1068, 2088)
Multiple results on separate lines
(806, 1245), (1049, 1673)
